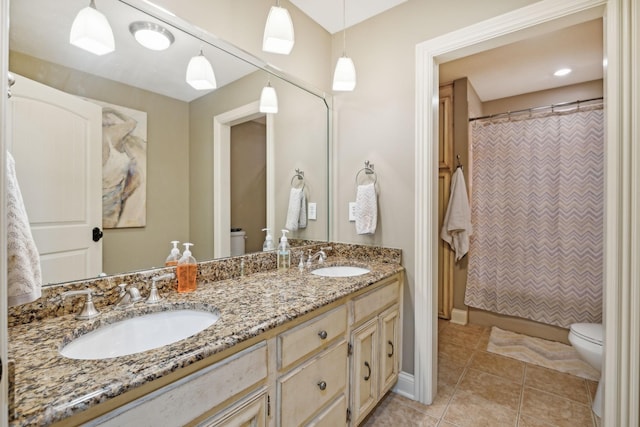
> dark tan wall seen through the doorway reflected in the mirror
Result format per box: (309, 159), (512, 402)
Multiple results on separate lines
(230, 120), (267, 253)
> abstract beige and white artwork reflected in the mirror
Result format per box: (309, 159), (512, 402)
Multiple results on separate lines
(94, 101), (147, 228)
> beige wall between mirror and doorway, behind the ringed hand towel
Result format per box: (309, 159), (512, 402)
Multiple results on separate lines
(331, 0), (535, 373)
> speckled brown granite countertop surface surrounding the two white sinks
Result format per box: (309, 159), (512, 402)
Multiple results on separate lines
(9, 259), (403, 426)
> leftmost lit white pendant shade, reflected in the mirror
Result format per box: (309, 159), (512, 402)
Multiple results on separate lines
(69, 0), (115, 55)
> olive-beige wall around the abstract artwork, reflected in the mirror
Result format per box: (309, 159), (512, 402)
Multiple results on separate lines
(9, 52), (189, 274)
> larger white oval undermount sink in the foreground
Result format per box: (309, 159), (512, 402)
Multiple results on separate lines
(60, 309), (220, 360)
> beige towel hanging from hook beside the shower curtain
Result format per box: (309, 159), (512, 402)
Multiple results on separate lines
(440, 168), (473, 261)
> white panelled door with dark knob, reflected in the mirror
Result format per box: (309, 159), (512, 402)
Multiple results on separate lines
(8, 76), (102, 284)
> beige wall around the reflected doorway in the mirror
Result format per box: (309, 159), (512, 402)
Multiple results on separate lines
(189, 72), (329, 259)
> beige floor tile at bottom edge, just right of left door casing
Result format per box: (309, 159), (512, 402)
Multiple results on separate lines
(443, 369), (522, 427)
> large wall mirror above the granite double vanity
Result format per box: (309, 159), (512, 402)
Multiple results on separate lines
(9, 0), (330, 283)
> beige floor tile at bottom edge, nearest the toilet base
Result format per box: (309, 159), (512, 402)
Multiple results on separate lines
(520, 387), (593, 427)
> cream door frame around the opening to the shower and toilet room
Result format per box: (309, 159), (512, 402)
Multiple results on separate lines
(414, 0), (640, 425)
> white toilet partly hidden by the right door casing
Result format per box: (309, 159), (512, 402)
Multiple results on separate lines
(569, 323), (604, 418)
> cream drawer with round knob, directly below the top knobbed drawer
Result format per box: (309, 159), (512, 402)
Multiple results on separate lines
(278, 341), (347, 427)
